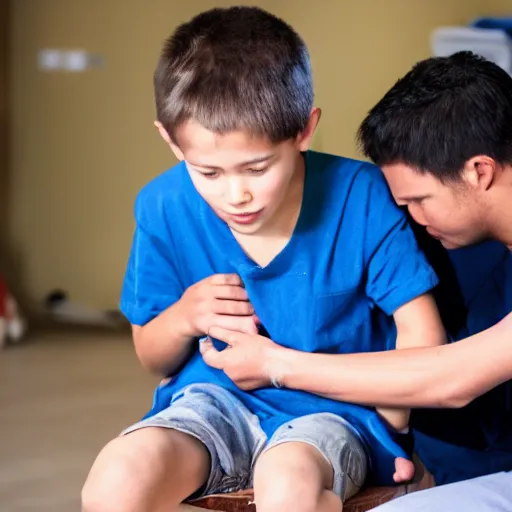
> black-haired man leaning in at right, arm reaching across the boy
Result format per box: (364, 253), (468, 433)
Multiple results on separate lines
(200, 52), (512, 512)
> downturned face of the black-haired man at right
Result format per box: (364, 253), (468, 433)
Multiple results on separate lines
(382, 163), (490, 249)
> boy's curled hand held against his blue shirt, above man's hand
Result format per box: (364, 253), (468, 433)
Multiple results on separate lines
(178, 274), (258, 338)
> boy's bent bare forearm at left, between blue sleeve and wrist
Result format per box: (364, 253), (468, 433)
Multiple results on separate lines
(133, 302), (193, 376)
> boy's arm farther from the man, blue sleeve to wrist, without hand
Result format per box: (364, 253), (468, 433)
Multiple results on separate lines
(120, 187), (192, 375)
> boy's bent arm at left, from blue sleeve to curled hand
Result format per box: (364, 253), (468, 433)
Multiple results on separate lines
(120, 188), (257, 376)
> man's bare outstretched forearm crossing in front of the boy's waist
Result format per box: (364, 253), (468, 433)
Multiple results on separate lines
(275, 315), (512, 408)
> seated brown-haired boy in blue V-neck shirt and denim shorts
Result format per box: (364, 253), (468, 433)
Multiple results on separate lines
(83, 7), (445, 512)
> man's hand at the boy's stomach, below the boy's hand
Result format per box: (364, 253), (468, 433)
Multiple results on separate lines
(199, 326), (286, 390)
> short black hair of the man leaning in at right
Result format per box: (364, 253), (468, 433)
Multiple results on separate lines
(358, 52), (512, 181)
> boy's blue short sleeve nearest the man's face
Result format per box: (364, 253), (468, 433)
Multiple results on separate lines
(365, 167), (438, 315)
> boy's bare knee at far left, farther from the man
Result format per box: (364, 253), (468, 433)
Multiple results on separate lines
(82, 427), (210, 512)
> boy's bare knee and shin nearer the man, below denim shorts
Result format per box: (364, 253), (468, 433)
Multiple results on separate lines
(254, 442), (342, 512)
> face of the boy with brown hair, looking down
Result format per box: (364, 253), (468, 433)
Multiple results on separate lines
(157, 111), (319, 235)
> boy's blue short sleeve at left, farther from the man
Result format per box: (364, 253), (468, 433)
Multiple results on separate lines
(120, 190), (183, 326)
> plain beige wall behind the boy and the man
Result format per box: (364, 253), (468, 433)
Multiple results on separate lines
(10, 0), (508, 307)
